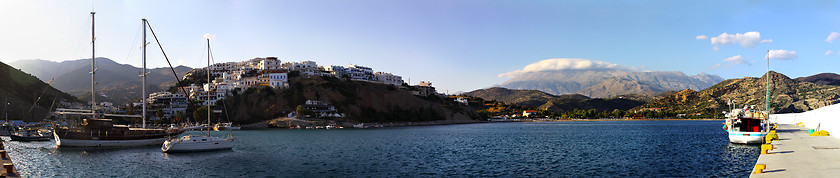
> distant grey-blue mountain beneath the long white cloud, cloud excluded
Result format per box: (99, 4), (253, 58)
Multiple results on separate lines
(500, 69), (722, 98)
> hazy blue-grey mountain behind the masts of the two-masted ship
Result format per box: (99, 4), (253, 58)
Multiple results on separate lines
(11, 58), (192, 104)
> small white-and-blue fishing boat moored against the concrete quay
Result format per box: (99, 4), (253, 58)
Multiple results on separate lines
(724, 51), (770, 144)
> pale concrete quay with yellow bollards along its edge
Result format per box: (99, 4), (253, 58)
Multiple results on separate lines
(750, 124), (840, 177)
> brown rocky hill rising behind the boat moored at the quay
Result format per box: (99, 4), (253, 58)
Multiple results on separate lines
(640, 71), (840, 113)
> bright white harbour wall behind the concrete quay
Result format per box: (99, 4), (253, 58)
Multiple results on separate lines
(770, 104), (840, 138)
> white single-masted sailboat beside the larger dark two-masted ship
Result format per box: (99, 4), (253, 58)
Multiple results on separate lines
(160, 35), (233, 152)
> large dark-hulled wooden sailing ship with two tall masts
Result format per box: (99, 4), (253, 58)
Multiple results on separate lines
(53, 12), (184, 147)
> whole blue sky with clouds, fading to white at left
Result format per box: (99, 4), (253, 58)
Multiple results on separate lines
(0, 0), (840, 93)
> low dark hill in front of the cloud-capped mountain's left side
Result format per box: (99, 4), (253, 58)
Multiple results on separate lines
(464, 87), (645, 112)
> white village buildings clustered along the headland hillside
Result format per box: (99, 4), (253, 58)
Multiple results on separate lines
(142, 57), (436, 118)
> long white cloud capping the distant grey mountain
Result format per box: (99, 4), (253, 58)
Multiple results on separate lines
(496, 58), (628, 78)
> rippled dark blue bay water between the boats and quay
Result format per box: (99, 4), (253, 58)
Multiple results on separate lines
(4, 121), (759, 177)
